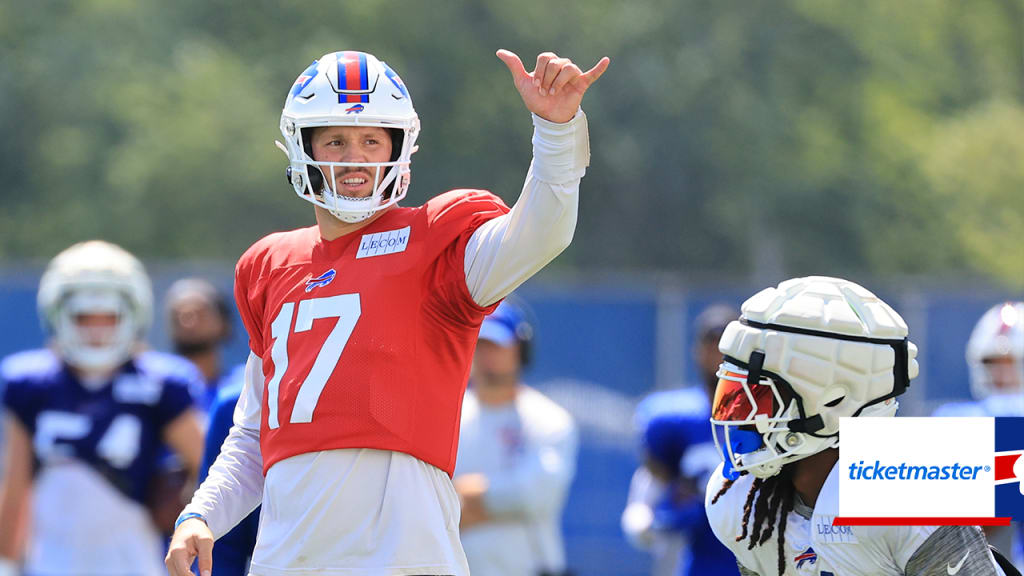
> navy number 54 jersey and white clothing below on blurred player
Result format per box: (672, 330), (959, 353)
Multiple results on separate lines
(0, 349), (202, 576)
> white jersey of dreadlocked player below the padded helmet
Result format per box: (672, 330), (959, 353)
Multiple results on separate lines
(706, 464), (1002, 576)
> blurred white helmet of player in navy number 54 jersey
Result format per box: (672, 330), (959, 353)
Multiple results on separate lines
(38, 240), (153, 373)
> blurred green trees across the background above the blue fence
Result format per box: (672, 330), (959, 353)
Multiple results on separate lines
(0, 0), (1024, 286)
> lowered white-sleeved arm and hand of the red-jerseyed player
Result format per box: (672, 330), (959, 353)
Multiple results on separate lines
(165, 354), (263, 576)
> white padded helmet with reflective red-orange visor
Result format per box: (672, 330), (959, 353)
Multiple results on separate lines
(711, 277), (918, 479)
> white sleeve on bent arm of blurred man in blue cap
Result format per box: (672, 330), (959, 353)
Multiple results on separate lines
(483, 409), (579, 518)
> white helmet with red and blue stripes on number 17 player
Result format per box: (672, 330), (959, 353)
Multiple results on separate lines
(278, 51), (420, 222)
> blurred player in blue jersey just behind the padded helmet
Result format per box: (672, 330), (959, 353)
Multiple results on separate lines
(622, 304), (739, 576)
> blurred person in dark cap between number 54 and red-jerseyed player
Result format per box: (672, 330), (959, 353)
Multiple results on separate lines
(165, 278), (245, 413)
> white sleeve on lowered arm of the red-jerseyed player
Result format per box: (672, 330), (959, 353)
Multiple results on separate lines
(184, 354), (264, 538)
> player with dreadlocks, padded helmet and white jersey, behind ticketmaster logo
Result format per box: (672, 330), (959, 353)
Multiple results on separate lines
(706, 277), (1001, 576)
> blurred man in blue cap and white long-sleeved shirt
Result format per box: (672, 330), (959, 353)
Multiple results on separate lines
(453, 300), (577, 576)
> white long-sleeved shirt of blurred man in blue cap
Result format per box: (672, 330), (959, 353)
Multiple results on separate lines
(455, 385), (579, 576)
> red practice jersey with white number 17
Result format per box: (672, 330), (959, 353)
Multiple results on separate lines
(234, 191), (508, 476)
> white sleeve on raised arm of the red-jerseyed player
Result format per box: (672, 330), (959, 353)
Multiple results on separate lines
(465, 110), (590, 306)
